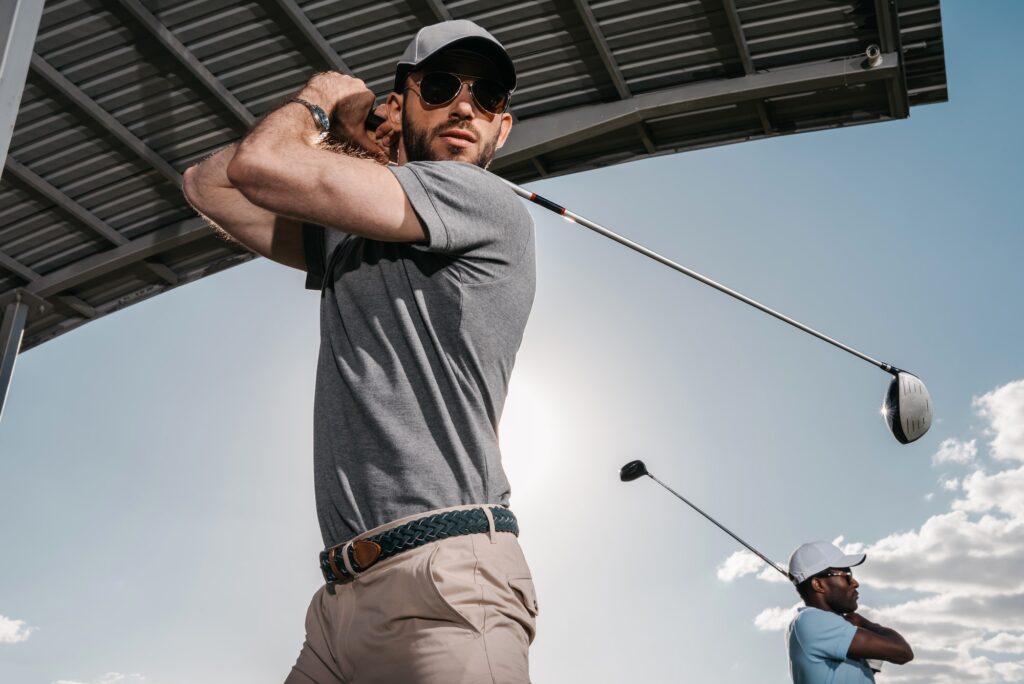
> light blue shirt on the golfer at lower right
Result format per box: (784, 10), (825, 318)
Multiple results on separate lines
(785, 606), (874, 684)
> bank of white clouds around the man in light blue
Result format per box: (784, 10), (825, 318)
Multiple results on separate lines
(719, 380), (1024, 684)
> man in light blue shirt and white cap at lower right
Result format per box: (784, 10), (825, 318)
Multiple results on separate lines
(785, 542), (913, 684)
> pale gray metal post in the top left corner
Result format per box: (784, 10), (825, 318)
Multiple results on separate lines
(0, 0), (43, 179)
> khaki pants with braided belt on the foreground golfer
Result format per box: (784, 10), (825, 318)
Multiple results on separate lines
(286, 506), (537, 684)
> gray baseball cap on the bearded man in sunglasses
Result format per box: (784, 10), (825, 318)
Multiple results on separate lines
(394, 19), (516, 91)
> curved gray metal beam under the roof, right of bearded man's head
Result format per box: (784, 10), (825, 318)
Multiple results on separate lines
(494, 52), (899, 167)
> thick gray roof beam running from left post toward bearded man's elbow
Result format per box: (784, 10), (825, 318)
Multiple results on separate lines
(25, 217), (207, 299)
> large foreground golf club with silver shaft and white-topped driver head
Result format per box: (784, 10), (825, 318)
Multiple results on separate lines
(506, 181), (932, 444)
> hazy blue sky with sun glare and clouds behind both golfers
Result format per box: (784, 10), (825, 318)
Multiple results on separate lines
(0, 1), (1024, 684)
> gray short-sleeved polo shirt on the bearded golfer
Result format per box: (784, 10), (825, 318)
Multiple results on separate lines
(303, 162), (536, 547)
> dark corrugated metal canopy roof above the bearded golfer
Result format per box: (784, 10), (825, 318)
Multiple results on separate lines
(0, 0), (947, 358)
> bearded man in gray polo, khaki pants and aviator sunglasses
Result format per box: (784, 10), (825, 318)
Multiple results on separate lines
(185, 22), (537, 684)
